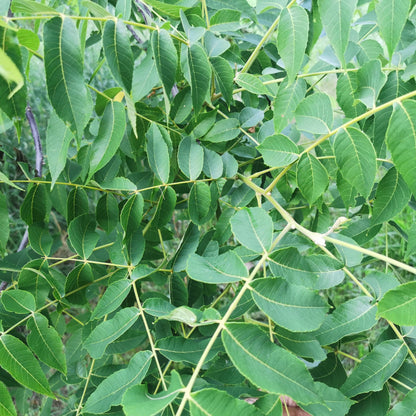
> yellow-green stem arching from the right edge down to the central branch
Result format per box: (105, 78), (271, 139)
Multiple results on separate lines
(266, 90), (416, 192)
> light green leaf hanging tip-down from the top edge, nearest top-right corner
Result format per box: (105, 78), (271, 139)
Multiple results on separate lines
(376, 0), (411, 59)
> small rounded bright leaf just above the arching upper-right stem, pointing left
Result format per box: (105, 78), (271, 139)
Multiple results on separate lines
(257, 134), (299, 168)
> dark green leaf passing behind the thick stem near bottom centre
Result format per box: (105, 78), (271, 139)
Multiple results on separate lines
(156, 336), (224, 365)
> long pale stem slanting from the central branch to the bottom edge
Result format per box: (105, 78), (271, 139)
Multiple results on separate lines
(176, 224), (291, 416)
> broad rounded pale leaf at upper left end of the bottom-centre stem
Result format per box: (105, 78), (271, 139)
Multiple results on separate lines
(230, 208), (273, 253)
